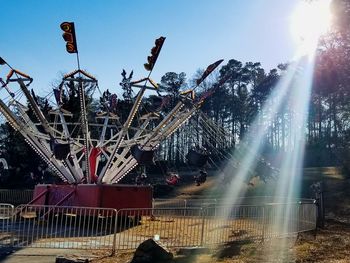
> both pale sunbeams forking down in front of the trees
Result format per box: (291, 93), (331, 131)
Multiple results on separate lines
(213, 24), (315, 261)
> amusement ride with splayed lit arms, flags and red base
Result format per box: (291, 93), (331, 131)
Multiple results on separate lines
(0, 22), (222, 208)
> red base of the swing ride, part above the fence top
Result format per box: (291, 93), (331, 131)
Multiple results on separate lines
(30, 184), (153, 210)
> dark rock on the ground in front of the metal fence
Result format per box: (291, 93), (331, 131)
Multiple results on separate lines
(130, 239), (174, 263)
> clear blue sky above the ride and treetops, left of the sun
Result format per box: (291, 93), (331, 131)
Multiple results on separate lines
(0, 0), (302, 95)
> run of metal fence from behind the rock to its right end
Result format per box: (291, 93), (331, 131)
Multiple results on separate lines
(116, 202), (316, 252)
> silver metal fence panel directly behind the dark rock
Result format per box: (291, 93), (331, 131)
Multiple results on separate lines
(116, 208), (203, 252)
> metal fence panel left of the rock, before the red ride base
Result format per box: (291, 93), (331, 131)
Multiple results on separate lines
(12, 205), (117, 254)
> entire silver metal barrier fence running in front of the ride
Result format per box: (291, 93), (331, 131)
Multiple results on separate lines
(0, 200), (316, 253)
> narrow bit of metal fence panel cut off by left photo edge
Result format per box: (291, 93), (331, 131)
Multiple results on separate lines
(0, 203), (14, 247)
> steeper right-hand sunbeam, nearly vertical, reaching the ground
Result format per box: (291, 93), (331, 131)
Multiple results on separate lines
(266, 54), (314, 261)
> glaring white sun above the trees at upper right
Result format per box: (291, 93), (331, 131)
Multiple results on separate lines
(290, 0), (332, 55)
